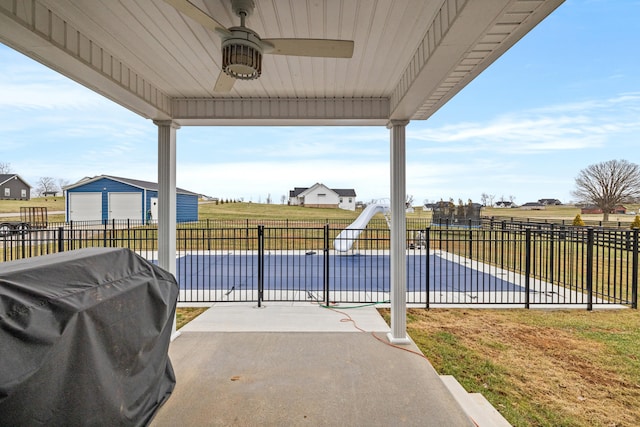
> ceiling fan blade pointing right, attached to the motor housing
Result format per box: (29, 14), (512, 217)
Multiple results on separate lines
(262, 39), (353, 58)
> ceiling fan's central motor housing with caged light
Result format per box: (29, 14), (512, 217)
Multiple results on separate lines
(222, 27), (262, 80)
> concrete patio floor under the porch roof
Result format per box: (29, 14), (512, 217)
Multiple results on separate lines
(151, 303), (496, 427)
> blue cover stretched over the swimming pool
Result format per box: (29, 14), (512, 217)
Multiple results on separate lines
(176, 252), (524, 292)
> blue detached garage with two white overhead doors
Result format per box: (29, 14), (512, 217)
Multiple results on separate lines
(64, 175), (198, 222)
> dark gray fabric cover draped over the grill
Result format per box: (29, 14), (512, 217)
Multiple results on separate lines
(0, 248), (178, 426)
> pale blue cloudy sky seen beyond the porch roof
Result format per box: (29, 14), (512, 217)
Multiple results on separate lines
(0, 0), (640, 204)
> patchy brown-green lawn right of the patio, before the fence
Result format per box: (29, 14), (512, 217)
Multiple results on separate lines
(380, 309), (640, 427)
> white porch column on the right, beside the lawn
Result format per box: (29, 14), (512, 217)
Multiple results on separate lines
(387, 120), (410, 344)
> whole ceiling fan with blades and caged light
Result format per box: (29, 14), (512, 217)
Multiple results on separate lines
(165, 0), (353, 92)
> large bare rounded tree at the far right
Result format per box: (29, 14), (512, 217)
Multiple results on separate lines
(573, 160), (640, 221)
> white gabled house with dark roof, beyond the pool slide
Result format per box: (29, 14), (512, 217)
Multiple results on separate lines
(289, 183), (356, 211)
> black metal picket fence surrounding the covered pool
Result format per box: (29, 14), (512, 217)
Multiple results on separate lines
(0, 220), (640, 309)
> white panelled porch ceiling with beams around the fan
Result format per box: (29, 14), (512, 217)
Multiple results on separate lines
(0, 0), (563, 126)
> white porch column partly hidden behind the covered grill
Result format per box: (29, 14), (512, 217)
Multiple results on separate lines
(153, 120), (180, 340)
